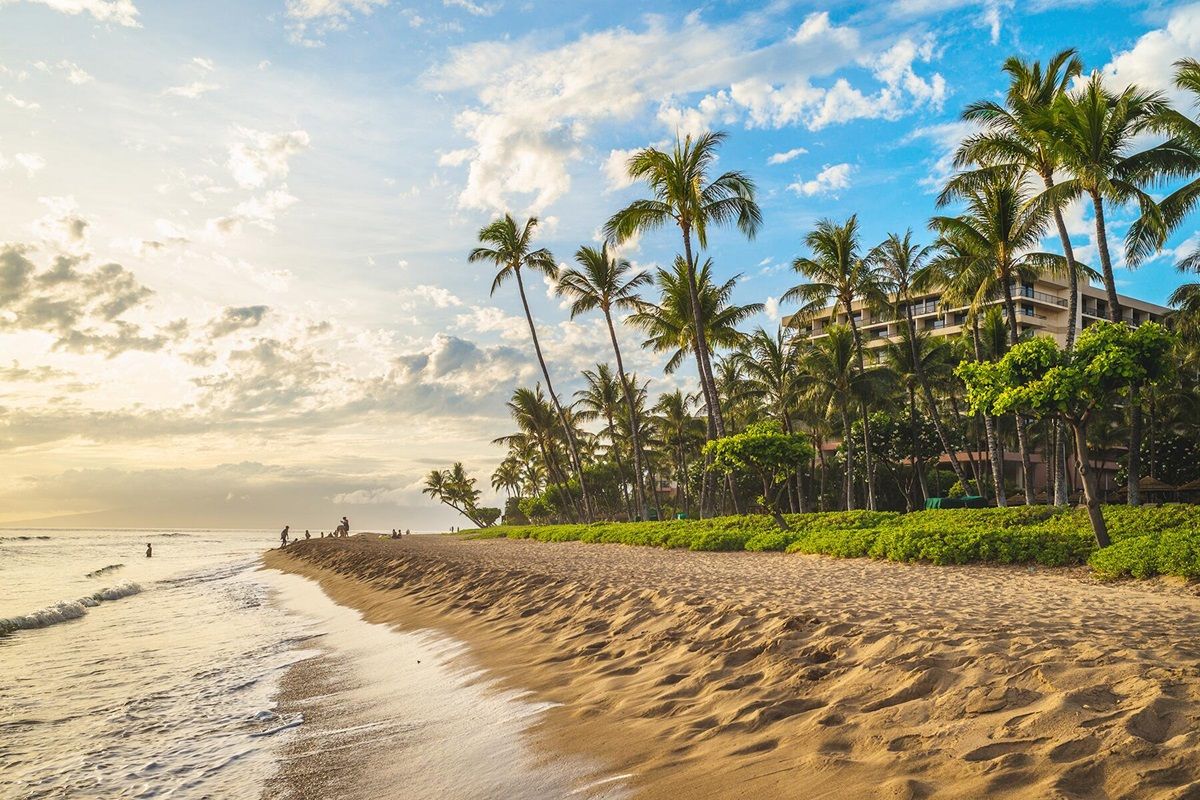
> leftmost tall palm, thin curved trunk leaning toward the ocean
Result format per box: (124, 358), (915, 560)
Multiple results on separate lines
(467, 213), (592, 518)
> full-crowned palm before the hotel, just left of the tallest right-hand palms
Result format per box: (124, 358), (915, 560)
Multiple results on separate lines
(930, 174), (1066, 505)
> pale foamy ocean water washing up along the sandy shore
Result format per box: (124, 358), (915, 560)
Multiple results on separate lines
(0, 529), (628, 800)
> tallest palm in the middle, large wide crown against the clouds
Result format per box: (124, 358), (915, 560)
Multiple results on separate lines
(605, 132), (762, 437)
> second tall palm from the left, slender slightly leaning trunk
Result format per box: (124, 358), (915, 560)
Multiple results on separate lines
(558, 243), (650, 518)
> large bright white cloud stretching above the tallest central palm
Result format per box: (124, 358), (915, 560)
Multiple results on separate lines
(426, 12), (946, 211)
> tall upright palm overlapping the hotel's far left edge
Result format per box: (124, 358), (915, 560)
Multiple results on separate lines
(782, 215), (887, 511)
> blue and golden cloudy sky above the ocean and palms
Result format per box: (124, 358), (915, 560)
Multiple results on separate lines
(0, 0), (1200, 530)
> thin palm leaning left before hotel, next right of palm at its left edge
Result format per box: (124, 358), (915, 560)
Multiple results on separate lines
(868, 230), (967, 487)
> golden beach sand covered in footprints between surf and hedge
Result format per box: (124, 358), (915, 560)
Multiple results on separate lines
(266, 536), (1200, 800)
